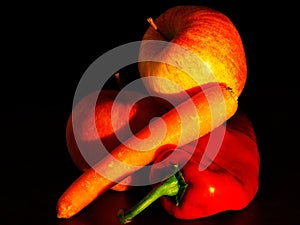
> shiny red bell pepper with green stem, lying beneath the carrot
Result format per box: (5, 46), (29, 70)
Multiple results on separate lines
(118, 111), (260, 224)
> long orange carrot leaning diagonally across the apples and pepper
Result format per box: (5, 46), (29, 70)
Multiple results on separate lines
(56, 85), (238, 218)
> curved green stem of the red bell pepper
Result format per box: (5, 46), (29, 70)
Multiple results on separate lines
(117, 166), (187, 224)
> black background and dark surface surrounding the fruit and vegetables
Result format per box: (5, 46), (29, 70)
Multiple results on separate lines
(0, 1), (300, 225)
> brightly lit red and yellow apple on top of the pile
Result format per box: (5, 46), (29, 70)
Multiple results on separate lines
(138, 5), (247, 102)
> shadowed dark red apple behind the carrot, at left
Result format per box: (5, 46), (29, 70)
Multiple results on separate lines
(66, 90), (166, 191)
